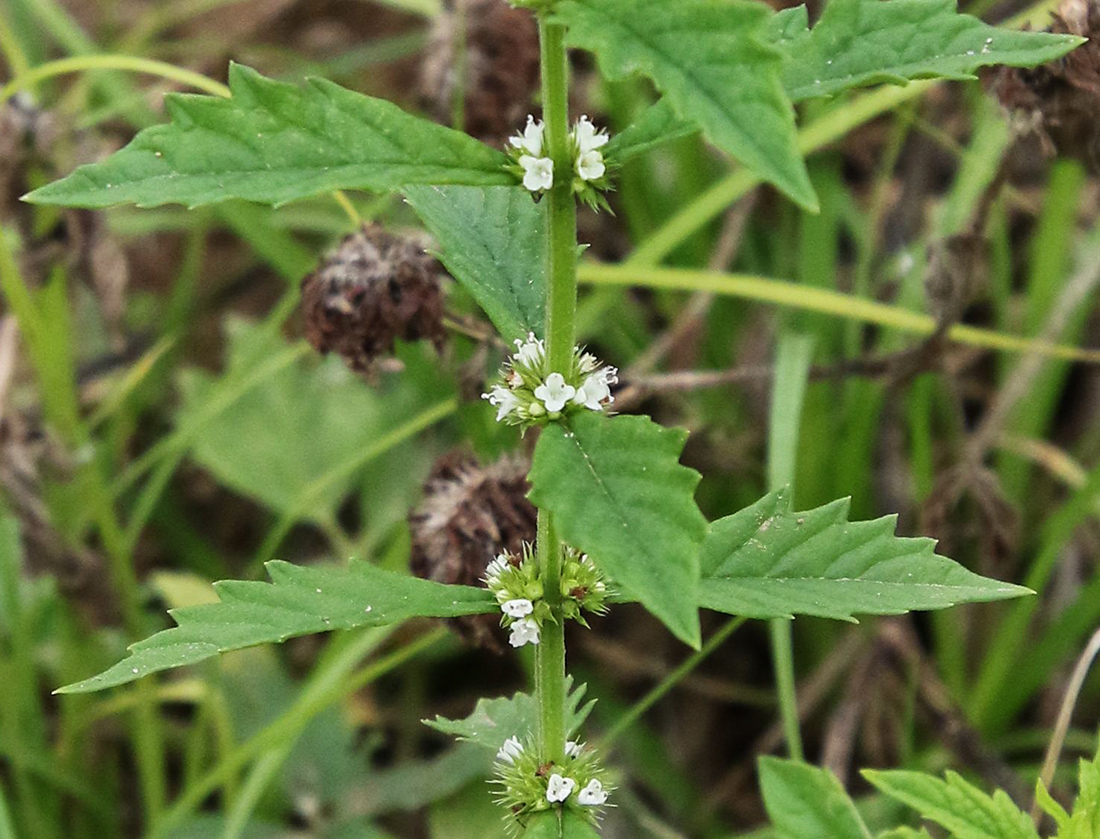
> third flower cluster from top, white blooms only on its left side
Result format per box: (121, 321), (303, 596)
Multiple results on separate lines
(485, 544), (609, 648)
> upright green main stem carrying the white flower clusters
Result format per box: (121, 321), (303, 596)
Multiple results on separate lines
(535, 15), (576, 762)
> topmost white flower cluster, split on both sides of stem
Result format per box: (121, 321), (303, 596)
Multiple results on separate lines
(508, 117), (611, 207)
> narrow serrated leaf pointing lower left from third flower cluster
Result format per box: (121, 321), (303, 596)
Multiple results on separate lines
(57, 562), (497, 693)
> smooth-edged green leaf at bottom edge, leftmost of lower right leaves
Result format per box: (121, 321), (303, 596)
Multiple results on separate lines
(758, 758), (871, 839)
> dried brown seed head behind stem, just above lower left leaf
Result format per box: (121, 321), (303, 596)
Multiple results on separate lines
(409, 452), (537, 652)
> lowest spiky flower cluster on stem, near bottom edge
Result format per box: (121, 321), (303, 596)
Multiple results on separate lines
(495, 737), (614, 828)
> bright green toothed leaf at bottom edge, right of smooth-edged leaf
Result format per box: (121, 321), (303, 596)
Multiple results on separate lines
(862, 770), (1038, 839)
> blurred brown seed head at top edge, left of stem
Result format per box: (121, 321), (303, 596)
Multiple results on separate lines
(420, 0), (539, 145)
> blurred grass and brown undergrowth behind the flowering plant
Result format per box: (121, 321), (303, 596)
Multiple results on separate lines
(0, 0), (1100, 839)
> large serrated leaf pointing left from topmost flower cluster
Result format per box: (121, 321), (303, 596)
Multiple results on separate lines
(28, 64), (515, 207)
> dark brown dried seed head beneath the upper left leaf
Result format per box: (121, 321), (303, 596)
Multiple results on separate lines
(301, 224), (447, 377)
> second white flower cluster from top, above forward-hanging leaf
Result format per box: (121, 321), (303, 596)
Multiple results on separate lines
(482, 333), (618, 426)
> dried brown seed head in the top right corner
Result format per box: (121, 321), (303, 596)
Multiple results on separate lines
(988, 0), (1100, 172)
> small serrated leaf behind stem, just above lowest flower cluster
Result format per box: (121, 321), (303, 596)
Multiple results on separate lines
(424, 676), (595, 752)
